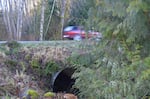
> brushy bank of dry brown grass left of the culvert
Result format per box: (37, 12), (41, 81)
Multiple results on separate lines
(0, 43), (72, 99)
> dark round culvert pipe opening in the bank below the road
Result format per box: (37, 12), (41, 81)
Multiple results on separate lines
(52, 68), (77, 93)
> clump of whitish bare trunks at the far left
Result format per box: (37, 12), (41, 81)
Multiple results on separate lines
(1, 0), (24, 40)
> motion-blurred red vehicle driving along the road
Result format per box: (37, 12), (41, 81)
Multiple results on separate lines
(63, 26), (102, 40)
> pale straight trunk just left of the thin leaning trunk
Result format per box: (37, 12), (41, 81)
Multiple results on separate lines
(40, 0), (45, 41)
